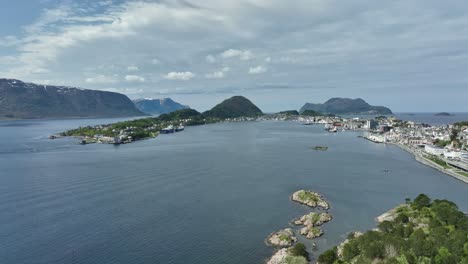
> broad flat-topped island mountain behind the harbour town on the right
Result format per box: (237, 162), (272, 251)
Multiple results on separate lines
(299, 98), (392, 115)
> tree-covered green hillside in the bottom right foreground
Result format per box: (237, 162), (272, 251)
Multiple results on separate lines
(318, 194), (468, 264)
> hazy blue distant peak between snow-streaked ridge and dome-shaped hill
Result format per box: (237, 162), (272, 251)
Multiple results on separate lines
(133, 98), (189, 115)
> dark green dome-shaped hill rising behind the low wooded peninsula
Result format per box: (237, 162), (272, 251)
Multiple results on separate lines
(203, 96), (263, 118)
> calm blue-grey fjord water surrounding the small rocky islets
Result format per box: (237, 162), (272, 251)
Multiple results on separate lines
(0, 119), (468, 264)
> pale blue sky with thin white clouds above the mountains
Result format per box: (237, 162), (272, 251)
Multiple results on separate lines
(0, 0), (468, 112)
